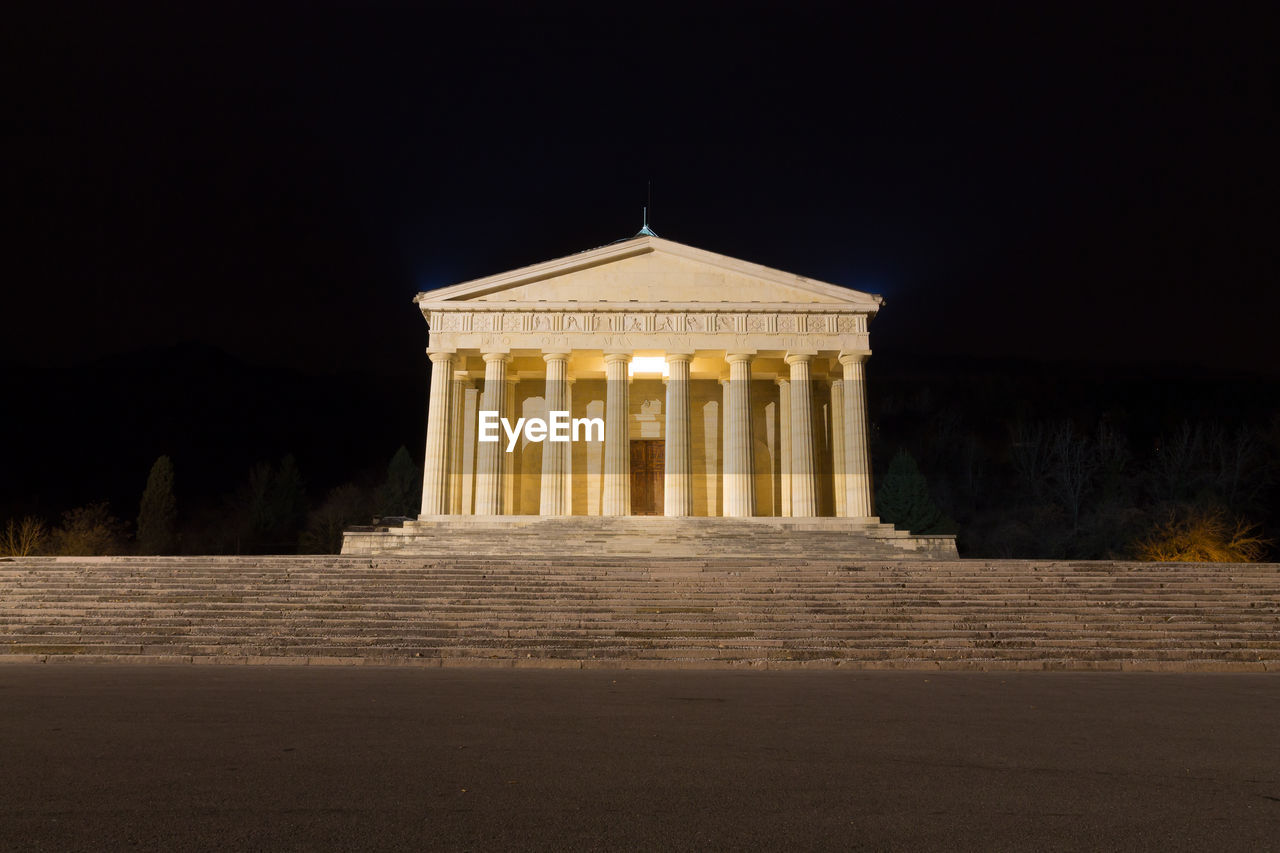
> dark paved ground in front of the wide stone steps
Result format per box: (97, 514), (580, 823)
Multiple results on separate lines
(0, 665), (1280, 850)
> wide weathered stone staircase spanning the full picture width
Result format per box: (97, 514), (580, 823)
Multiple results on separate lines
(0, 548), (1280, 671)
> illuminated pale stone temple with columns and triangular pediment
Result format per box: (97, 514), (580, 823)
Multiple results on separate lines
(344, 227), (954, 553)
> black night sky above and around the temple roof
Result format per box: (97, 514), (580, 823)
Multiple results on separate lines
(0, 3), (1280, 373)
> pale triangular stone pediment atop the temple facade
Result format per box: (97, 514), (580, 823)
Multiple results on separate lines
(416, 236), (882, 314)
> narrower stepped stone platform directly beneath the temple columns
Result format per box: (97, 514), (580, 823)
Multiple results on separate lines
(342, 515), (957, 560)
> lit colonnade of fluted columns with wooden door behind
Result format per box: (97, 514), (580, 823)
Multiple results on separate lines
(422, 347), (872, 517)
